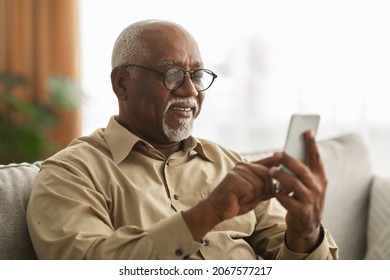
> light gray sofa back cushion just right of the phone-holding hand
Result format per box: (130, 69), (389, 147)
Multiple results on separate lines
(319, 134), (373, 259)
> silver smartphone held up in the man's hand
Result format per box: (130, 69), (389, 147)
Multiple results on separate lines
(275, 114), (320, 192)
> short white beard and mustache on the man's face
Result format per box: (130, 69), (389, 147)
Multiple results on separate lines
(162, 97), (199, 142)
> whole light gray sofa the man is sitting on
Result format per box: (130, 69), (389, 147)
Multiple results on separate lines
(0, 134), (390, 259)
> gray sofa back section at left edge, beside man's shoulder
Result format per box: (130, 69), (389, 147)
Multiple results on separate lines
(0, 162), (40, 260)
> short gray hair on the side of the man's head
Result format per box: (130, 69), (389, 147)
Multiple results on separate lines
(111, 20), (150, 69)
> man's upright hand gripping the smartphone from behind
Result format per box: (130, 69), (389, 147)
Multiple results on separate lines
(271, 131), (327, 253)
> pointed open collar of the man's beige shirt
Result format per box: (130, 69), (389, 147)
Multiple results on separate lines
(104, 116), (212, 164)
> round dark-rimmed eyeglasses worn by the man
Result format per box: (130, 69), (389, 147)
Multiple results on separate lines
(122, 64), (218, 92)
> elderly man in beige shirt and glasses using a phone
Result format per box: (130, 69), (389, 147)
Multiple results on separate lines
(27, 20), (338, 259)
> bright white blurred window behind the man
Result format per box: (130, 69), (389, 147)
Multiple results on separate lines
(80, 0), (390, 174)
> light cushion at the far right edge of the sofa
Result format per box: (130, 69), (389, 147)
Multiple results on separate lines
(366, 176), (390, 260)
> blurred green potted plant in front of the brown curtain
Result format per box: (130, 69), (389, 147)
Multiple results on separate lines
(0, 72), (83, 164)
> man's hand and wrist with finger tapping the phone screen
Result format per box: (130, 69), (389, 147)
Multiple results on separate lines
(183, 157), (279, 241)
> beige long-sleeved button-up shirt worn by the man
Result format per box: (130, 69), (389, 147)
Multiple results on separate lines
(27, 117), (338, 260)
